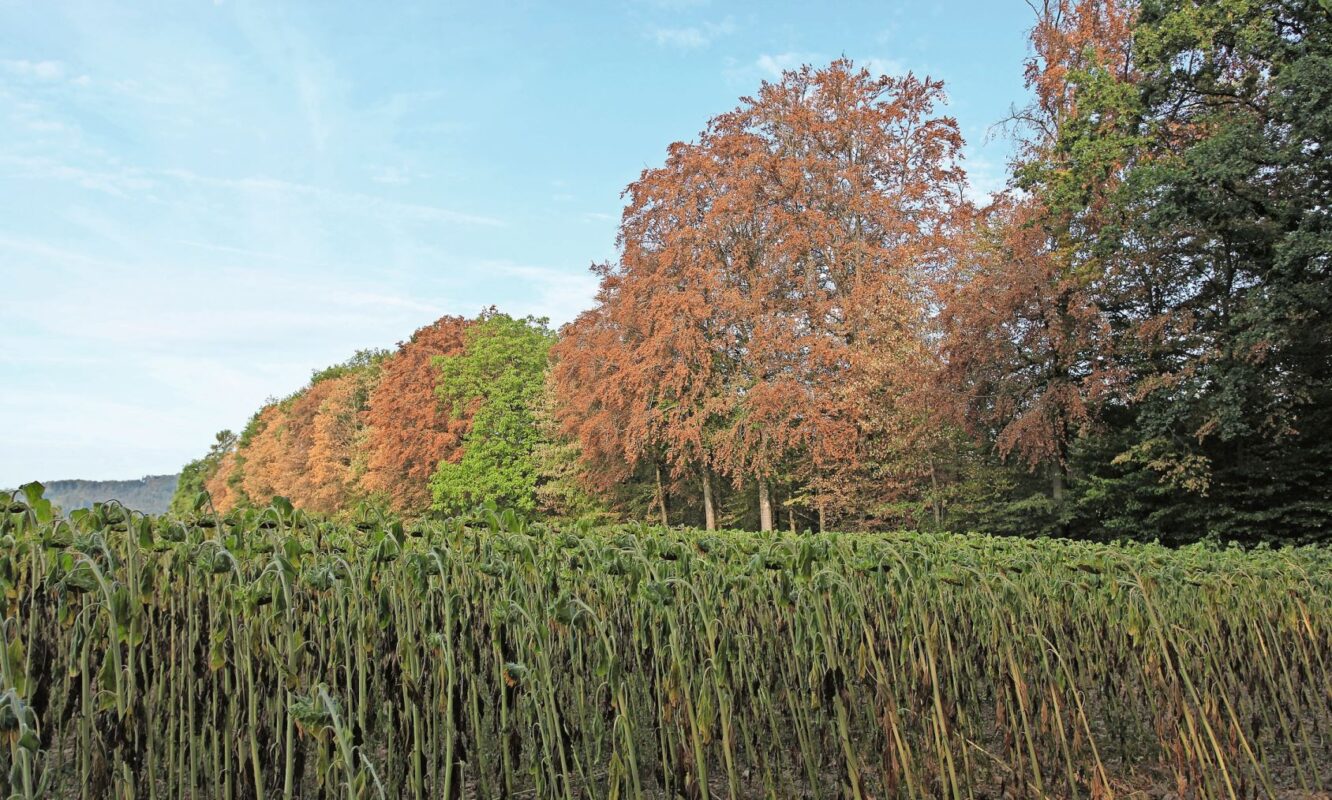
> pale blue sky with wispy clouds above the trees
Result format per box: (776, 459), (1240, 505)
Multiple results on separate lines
(0, 0), (1032, 487)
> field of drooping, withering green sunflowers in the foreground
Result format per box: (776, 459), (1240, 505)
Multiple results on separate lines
(0, 489), (1332, 800)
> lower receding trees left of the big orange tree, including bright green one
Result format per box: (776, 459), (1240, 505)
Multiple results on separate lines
(172, 309), (554, 514)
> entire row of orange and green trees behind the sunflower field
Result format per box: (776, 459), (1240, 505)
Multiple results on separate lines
(177, 0), (1332, 542)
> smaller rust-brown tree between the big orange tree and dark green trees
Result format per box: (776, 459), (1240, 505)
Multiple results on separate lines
(943, 194), (1115, 479)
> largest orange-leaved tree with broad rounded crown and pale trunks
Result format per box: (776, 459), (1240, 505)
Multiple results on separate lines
(554, 60), (963, 528)
